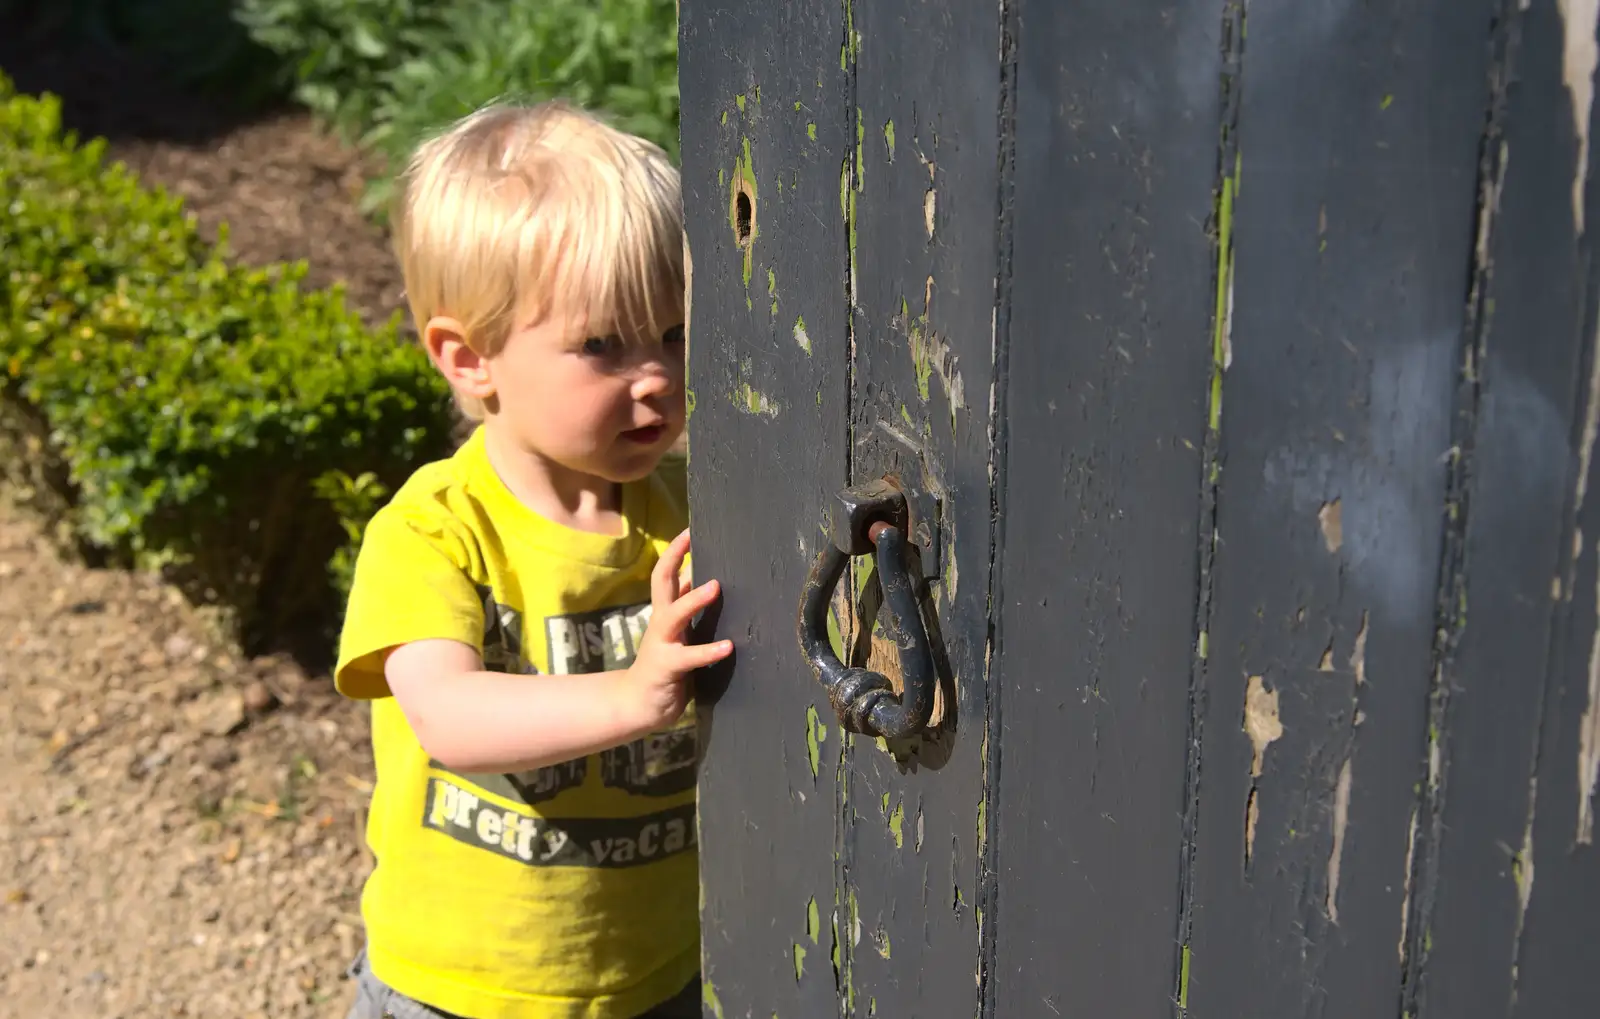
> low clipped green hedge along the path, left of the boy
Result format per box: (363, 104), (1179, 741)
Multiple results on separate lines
(0, 75), (451, 646)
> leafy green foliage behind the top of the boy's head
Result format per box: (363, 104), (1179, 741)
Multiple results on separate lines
(238, 0), (678, 211)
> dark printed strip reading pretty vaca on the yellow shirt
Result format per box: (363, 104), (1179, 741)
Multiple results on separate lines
(422, 776), (696, 867)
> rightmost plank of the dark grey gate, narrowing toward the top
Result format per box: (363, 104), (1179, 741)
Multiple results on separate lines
(1418, 0), (1600, 1019)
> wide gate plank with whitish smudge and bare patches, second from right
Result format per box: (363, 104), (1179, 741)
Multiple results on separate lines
(1179, 0), (1491, 1019)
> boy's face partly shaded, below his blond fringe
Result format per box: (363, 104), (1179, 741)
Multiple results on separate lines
(485, 294), (685, 483)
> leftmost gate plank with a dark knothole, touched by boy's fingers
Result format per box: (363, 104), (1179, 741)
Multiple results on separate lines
(680, 0), (854, 1019)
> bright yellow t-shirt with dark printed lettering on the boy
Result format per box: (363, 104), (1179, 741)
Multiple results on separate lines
(334, 429), (699, 1019)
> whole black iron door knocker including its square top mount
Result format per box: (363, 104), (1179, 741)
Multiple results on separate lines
(798, 480), (938, 739)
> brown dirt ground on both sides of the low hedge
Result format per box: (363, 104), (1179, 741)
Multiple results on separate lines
(0, 23), (400, 1019)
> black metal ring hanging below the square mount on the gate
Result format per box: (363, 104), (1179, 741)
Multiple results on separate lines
(798, 520), (936, 739)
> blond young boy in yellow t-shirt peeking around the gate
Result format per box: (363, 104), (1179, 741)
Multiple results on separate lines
(334, 102), (733, 1019)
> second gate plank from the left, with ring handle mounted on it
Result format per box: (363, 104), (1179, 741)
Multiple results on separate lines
(835, 0), (1002, 1016)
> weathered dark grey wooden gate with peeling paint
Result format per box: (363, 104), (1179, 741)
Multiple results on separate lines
(680, 0), (1600, 1019)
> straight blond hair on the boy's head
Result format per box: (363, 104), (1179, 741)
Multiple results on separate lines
(390, 99), (683, 419)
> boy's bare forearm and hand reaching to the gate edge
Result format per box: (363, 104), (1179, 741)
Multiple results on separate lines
(384, 531), (733, 773)
